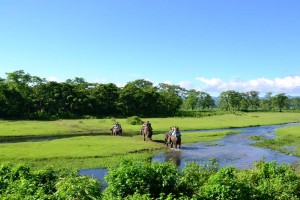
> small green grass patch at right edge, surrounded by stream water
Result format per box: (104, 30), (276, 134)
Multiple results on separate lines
(254, 126), (300, 156)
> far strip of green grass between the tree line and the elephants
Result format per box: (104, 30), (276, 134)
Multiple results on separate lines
(0, 112), (300, 139)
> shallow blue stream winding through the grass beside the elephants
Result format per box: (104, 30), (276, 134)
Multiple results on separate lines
(79, 123), (300, 182)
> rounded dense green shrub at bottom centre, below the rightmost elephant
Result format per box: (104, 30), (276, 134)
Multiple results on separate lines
(105, 160), (179, 198)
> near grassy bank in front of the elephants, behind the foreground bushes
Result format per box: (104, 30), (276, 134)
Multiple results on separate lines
(0, 131), (236, 169)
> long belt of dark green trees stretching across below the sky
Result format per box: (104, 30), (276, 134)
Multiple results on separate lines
(0, 70), (300, 119)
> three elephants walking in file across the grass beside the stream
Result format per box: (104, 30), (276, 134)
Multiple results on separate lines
(110, 122), (181, 149)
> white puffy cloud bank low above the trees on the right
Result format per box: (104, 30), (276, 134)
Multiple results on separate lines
(196, 75), (300, 95)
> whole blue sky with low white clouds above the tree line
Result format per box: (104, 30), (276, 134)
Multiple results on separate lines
(0, 0), (300, 95)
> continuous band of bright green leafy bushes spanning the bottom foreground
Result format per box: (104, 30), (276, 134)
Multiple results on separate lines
(0, 159), (300, 200)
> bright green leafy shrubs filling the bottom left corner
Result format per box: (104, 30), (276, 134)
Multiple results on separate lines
(0, 163), (101, 200)
